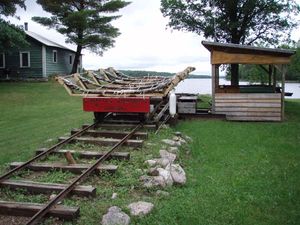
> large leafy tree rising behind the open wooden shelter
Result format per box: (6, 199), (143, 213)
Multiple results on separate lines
(161, 0), (300, 85)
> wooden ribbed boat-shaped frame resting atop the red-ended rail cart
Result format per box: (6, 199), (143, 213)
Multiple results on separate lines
(56, 67), (195, 97)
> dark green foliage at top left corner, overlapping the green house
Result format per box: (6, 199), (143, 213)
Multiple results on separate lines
(0, 0), (28, 52)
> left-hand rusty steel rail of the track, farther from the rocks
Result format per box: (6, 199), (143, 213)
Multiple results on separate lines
(0, 122), (97, 183)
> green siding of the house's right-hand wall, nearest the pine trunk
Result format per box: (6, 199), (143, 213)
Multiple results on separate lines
(46, 47), (75, 76)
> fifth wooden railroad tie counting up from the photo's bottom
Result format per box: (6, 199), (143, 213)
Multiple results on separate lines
(59, 137), (144, 148)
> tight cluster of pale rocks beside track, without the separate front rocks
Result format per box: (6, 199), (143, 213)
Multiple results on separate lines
(140, 132), (190, 188)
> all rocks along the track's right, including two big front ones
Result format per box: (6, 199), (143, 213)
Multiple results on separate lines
(101, 132), (191, 225)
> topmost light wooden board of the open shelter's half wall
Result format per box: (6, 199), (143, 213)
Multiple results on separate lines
(215, 93), (281, 99)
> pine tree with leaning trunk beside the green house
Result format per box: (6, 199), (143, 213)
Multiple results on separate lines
(32, 0), (129, 73)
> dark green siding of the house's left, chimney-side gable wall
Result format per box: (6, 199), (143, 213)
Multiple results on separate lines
(0, 38), (42, 79)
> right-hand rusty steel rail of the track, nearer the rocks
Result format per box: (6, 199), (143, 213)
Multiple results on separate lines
(26, 123), (143, 225)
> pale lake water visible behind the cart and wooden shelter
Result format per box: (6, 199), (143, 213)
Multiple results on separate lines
(175, 78), (300, 98)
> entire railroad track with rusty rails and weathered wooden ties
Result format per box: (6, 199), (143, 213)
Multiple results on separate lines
(0, 117), (157, 225)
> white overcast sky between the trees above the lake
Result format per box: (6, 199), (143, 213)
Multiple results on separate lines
(11, 0), (300, 74)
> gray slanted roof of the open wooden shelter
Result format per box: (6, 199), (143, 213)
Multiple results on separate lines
(201, 41), (295, 56)
